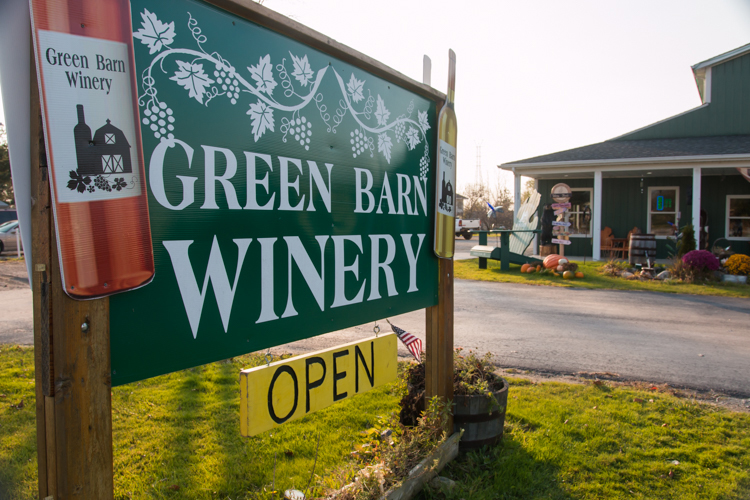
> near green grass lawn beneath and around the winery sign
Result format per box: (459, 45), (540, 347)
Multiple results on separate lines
(0, 346), (750, 500)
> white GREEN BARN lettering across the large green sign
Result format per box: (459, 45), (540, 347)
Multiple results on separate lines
(149, 139), (427, 216)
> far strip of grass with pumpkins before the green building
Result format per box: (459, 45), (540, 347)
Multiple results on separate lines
(454, 259), (750, 297)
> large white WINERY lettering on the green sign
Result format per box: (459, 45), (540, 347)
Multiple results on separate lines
(163, 234), (425, 338)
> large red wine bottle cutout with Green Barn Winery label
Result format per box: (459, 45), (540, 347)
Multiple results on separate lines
(31, 0), (154, 299)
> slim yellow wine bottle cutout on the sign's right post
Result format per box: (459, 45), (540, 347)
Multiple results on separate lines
(435, 50), (458, 259)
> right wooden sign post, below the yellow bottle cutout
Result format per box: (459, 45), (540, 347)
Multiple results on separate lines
(425, 259), (453, 435)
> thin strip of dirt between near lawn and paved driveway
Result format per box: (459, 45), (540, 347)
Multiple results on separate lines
(495, 368), (750, 413)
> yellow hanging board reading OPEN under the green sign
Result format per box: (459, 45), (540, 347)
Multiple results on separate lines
(240, 333), (398, 436)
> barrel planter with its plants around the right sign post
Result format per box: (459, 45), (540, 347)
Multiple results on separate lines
(400, 348), (508, 451)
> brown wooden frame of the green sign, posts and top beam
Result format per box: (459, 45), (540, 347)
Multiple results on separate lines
(29, 0), (453, 500)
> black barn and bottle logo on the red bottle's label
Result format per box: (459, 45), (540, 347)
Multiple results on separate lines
(68, 104), (135, 193)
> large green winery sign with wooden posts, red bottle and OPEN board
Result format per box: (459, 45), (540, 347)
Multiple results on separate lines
(22, 0), (455, 500)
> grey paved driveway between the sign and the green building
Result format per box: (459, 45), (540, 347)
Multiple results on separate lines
(0, 258), (750, 397)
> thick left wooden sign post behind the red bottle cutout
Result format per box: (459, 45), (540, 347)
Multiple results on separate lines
(29, 52), (114, 500)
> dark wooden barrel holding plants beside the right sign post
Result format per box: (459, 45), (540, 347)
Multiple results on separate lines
(453, 379), (508, 451)
